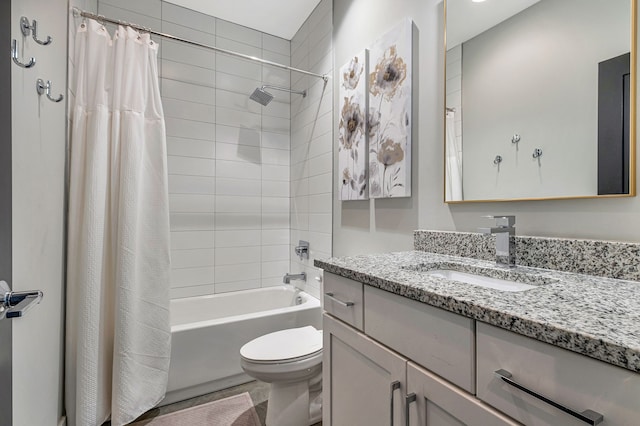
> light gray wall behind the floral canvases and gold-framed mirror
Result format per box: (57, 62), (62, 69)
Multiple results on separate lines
(333, 0), (640, 256)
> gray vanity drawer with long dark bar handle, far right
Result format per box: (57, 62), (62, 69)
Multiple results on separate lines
(476, 322), (640, 426)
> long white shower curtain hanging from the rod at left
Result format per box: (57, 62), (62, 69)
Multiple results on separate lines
(65, 20), (171, 426)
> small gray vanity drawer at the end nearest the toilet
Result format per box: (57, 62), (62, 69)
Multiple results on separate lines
(323, 272), (363, 330)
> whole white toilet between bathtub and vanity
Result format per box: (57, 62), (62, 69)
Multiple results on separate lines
(240, 326), (322, 426)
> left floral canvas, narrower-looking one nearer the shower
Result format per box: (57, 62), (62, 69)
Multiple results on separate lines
(338, 51), (369, 200)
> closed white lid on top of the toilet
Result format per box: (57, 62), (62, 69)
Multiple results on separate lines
(240, 326), (322, 361)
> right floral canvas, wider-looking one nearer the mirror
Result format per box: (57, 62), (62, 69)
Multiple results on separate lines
(367, 19), (413, 198)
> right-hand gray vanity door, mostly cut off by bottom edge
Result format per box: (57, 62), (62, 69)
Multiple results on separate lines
(407, 362), (520, 426)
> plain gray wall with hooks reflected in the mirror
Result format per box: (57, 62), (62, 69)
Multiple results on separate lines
(460, 0), (630, 200)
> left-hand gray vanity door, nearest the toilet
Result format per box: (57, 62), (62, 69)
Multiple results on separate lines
(322, 314), (406, 426)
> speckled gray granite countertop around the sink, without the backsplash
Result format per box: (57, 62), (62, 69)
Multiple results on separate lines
(315, 251), (640, 372)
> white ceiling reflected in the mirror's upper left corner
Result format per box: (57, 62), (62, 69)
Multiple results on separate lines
(447, 0), (540, 49)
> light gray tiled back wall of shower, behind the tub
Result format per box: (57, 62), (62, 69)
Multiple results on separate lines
(85, 0), (292, 298)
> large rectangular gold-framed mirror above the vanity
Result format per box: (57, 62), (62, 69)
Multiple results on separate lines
(445, 0), (636, 202)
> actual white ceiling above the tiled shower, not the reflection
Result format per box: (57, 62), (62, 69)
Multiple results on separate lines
(162, 0), (320, 40)
